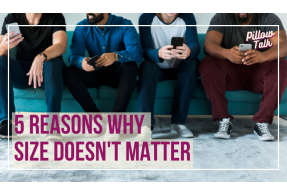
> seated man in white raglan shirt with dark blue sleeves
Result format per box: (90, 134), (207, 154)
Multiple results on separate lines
(136, 13), (199, 141)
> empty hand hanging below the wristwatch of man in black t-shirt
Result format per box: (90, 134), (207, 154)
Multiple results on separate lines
(27, 55), (45, 88)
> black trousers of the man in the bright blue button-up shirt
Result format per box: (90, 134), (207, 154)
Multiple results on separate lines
(64, 62), (138, 112)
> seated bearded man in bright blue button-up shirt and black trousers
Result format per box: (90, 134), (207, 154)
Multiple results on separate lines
(64, 13), (143, 141)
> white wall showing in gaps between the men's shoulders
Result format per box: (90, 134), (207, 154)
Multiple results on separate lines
(0, 13), (287, 33)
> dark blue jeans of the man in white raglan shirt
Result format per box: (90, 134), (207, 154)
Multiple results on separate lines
(138, 58), (199, 127)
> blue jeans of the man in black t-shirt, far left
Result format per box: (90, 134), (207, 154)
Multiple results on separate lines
(0, 56), (66, 123)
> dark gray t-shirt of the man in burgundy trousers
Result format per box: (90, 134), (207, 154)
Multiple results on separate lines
(207, 13), (284, 52)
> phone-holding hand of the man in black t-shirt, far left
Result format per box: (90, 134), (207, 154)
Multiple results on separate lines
(0, 31), (24, 54)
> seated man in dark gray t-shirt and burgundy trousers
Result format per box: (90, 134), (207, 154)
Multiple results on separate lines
(199, 13), (287, 141)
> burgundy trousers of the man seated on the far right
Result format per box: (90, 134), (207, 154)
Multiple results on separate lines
(199, 55), (287, 124)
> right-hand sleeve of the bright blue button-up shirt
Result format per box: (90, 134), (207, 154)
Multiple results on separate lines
(116, 22), (143, 63)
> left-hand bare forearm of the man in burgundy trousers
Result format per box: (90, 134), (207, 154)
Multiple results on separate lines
(204, 42), (228, 59)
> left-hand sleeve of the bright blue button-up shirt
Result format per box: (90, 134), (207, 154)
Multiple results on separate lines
(68, 24), (86, 69)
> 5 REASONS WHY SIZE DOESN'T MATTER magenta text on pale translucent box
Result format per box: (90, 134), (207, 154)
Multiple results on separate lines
(12, 113), (196, 169)
